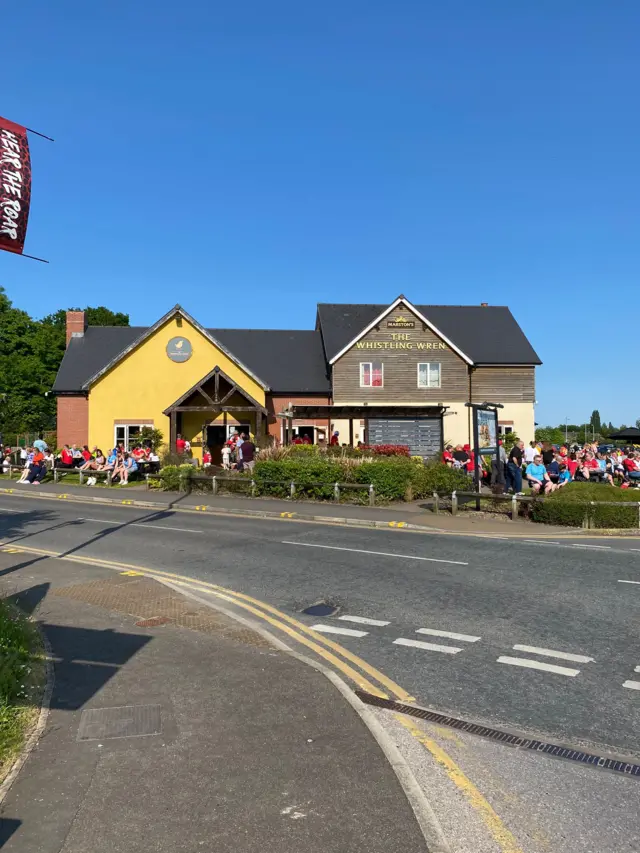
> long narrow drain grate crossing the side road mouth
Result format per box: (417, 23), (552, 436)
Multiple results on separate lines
(355, 690), (640, 779)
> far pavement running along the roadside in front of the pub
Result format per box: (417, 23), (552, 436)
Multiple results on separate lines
(0, 480), (624, 539)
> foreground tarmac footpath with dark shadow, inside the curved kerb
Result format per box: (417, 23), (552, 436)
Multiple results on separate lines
(0, 554), (427, 853)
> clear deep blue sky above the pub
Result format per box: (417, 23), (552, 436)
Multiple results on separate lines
(0, 0), (640, 424)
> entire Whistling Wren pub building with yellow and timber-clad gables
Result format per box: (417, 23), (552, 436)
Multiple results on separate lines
(53, 296), (541, 464)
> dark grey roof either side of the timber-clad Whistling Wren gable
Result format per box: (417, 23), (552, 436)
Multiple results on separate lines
(318, 304), (542, 364)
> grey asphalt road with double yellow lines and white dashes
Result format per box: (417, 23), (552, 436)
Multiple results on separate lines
(0, 494), (640, 853)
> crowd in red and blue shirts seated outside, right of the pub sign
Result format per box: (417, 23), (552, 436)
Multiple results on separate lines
(443, 441), (640, 495)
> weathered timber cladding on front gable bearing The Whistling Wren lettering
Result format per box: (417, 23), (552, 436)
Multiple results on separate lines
(333, 312), (469, 405)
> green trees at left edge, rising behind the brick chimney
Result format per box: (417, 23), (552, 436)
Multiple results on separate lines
(0, 287), (129, 434)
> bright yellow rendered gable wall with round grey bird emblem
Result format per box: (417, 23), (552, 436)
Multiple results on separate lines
(89, 318), (265, 456)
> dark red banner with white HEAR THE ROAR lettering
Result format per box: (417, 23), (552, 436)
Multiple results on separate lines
(0, 116), (31, 254)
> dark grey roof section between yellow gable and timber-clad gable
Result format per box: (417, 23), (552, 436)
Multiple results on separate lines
(208, 329), (331, 394)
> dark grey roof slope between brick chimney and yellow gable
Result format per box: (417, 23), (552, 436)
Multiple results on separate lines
(53, 326), (147, 393)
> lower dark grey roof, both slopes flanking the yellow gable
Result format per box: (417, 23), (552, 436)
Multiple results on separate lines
(53, 326), (331, 394)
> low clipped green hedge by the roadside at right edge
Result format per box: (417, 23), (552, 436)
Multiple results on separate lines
(531, 483), (640, 528)
